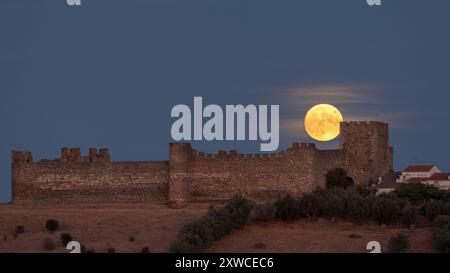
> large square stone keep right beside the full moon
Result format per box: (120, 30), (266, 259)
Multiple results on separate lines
(341, 121), (393, 184)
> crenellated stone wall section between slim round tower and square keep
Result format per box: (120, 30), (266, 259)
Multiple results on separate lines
(189, 144), (317, 200)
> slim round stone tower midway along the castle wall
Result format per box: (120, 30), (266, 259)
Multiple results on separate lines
(168, 142), (192, 208)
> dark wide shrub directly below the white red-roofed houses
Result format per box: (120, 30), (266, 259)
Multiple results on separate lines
(394, 183), (442, 205)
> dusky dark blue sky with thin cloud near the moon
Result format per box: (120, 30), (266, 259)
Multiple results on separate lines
(0, 0), (450, 202)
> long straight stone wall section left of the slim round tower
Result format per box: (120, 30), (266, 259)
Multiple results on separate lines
(12, 158), (168, 204)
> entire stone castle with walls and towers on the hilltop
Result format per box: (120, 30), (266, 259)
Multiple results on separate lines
(12, 121), (393, 207)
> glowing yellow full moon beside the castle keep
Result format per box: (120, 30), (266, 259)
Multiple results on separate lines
(305, 104), (344, 141)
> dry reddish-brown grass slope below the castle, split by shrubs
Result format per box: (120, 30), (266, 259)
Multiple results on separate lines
(0, 203), (432, 253)
